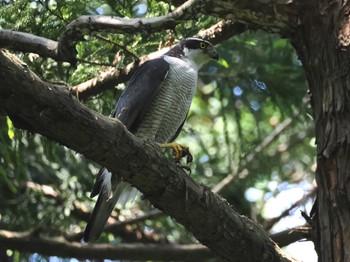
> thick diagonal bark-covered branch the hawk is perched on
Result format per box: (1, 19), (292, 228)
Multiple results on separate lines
(0, 49), (291, 262)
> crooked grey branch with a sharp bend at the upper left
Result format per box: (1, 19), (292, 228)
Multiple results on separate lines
(0, 0), (202, 66)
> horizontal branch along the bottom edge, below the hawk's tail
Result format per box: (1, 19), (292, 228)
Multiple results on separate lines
(0, 230), (214, 261)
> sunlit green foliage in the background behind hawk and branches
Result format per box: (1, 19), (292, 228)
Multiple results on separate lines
(0, 0), (315, 258)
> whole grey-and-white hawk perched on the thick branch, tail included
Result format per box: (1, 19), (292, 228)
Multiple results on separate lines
(83, 37), (219, 242)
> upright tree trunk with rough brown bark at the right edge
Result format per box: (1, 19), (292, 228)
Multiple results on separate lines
(292, 1), (350, 262)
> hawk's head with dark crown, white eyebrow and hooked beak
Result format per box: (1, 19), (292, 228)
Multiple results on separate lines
(168, 37), (219, 69)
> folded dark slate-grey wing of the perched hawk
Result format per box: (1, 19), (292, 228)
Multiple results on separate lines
(112, 58), (169, 132)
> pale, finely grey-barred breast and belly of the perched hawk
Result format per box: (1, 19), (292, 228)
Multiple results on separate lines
(135, 56), (198, 143)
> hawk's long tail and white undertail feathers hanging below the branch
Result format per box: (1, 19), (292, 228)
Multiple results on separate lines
(83, 168), (139, 242)
